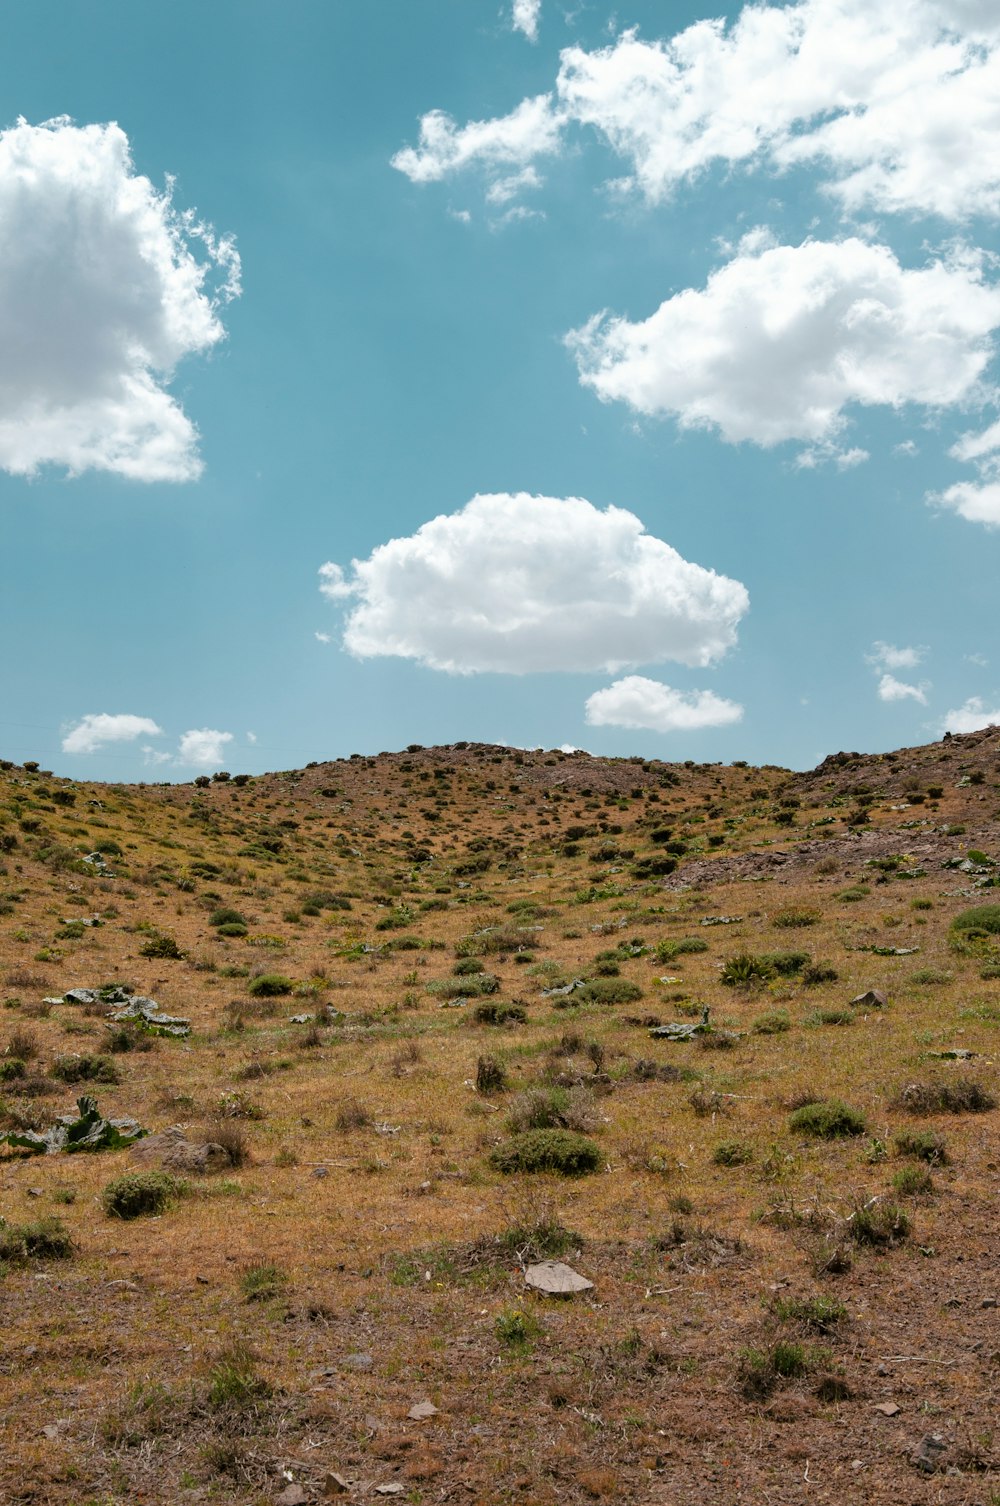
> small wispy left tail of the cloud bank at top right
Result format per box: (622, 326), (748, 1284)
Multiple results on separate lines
(392, 95), (562, 184)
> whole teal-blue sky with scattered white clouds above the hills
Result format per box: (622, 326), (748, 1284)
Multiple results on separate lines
(0, 0), (1000, 782)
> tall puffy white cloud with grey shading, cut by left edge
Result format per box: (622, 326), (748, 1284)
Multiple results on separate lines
(0, 117), (239, 482)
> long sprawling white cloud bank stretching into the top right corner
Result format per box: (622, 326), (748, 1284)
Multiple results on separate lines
(395, 0), (1000, 221)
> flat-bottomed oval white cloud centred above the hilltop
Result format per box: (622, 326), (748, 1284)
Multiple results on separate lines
(319, 492), (748, 675)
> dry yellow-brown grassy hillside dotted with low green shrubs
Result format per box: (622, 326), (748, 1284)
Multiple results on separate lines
(0, 730), (1000, 1506)
